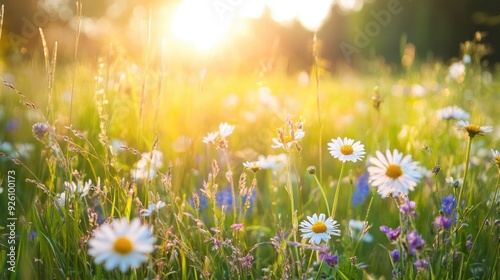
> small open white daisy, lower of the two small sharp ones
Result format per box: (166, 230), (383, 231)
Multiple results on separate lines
(300, 213), (340, 244)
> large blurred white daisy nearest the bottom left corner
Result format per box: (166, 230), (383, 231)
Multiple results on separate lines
(88, 218), (156, 272)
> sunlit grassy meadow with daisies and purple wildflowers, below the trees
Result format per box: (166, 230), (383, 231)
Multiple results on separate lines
(0, 17), (500, 279)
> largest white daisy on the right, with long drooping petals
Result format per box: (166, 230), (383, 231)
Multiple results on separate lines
(368, 150), (422, 198)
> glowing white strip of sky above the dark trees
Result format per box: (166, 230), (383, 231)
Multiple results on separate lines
(172, 0), (363, 50)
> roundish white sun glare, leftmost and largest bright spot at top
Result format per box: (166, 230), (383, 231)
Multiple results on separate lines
(172, 0), (229, 51)
